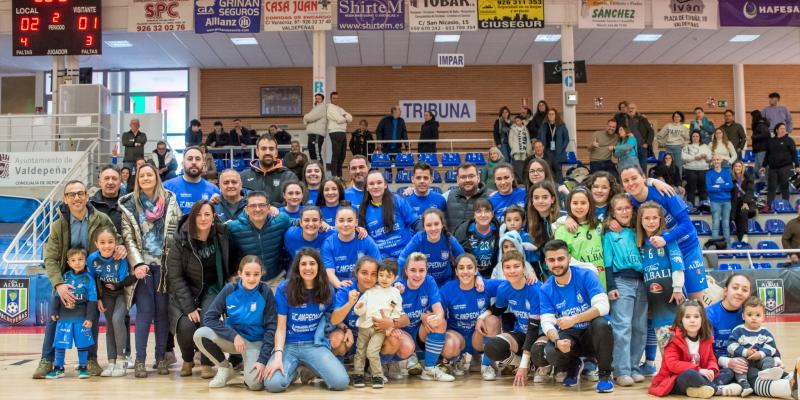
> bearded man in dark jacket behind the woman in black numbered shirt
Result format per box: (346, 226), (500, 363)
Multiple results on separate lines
(445, 162), (494, 231)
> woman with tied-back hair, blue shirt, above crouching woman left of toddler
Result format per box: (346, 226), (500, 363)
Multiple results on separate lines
(321, 205), (381, 289)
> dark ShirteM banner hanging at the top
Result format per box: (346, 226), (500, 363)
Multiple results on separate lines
(337, 0), (406, 31)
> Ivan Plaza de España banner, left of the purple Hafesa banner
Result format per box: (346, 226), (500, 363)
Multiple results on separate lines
(653, 0), (719, 29)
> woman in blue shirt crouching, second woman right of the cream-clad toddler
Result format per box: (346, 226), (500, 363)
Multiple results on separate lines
(439, 253), (502, 376)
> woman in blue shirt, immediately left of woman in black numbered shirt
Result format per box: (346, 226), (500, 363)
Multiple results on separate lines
(397, 208), (464, 287)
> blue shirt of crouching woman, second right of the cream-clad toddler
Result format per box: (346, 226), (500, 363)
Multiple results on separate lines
(439, 279), (504, 341)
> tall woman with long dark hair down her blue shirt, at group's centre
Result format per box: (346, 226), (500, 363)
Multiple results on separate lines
(358, 170), (419, 258)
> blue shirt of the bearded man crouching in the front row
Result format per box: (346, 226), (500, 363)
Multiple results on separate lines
(539, 267), (608, 329)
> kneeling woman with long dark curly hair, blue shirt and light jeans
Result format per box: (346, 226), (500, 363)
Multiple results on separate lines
(264, 249), (350, 393)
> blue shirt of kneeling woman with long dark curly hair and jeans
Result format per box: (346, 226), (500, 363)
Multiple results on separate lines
(275, 280), (333, 343)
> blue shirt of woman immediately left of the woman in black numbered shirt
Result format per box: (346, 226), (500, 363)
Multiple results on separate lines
(397, 232), (464, 286)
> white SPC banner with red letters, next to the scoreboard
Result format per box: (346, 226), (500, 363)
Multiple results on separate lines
(128, 0), (194, 32)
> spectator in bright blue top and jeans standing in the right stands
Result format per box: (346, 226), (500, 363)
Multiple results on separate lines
(706, 155), (733, 246)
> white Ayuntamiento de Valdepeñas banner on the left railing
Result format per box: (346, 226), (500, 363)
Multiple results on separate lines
(0, 151), (83, 187)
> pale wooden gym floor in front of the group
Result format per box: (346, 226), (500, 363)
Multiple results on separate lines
(0, 318), (800, 400)
